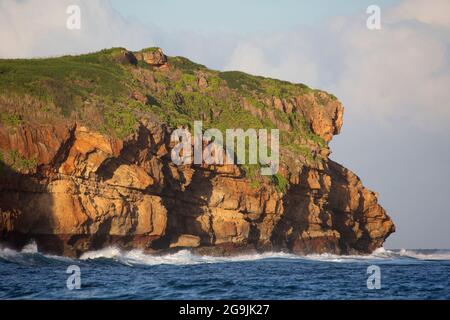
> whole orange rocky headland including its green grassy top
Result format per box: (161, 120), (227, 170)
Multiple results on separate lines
(0, 48), (394, 256)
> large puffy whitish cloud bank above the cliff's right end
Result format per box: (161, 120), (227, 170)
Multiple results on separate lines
(227, 0), (450, 130)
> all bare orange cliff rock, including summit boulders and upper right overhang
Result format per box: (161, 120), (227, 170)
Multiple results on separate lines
(0, 50), (394, 256)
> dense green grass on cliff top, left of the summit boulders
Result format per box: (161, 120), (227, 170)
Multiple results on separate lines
(0, 49), (128, 116)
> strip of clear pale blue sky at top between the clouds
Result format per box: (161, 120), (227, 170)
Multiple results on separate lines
(111, 0), (396, 33)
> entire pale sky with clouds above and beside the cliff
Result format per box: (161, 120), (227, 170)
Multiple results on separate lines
(0, 0), (450, 248)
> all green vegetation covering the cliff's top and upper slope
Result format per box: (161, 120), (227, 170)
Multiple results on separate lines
(0, 48), (336, 185)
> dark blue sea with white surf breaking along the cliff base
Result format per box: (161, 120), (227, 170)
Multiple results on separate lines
(0, 247), (450, 299)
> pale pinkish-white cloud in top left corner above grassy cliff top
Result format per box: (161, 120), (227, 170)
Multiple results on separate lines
(0, 0), (156, 58)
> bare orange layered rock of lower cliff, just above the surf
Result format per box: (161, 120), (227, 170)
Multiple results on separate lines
(0, 117), (394, 256)
